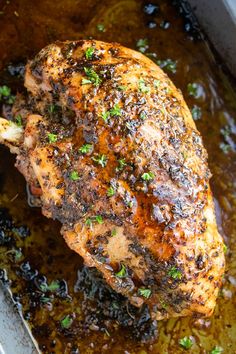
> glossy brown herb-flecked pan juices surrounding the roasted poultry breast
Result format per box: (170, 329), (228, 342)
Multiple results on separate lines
(0, 0), (236, 354)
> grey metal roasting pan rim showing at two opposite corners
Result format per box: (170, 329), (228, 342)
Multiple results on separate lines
(0, 0), (236, 354)
